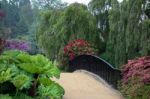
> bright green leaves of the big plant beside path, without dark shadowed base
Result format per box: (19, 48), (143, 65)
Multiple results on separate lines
(0, 51), (64, 99)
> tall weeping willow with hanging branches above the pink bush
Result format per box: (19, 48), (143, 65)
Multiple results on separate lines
(106, 0), (150, 68)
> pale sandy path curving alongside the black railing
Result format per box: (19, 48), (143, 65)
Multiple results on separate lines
(56, 71), (123, 99)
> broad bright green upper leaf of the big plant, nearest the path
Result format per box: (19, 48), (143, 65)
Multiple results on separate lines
(18, 55), (60, 78)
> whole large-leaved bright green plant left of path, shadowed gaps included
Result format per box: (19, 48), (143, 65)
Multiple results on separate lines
(0, 50), (64, 99)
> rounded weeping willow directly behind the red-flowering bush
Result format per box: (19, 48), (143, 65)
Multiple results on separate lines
(38, 3), (100, 59)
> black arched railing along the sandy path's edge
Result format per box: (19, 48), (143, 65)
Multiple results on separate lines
(69, 55), (121, 88)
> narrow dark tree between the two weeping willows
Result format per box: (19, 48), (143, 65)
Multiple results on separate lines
(88, 0), (111, 53)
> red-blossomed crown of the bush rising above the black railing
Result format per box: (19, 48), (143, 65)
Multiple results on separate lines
(64, 39), (96, 60)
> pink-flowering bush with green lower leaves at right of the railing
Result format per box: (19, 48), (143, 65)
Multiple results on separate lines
(120, 56), (150, 99)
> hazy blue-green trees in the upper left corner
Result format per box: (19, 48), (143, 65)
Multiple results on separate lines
(0, 0), (33, 38)
